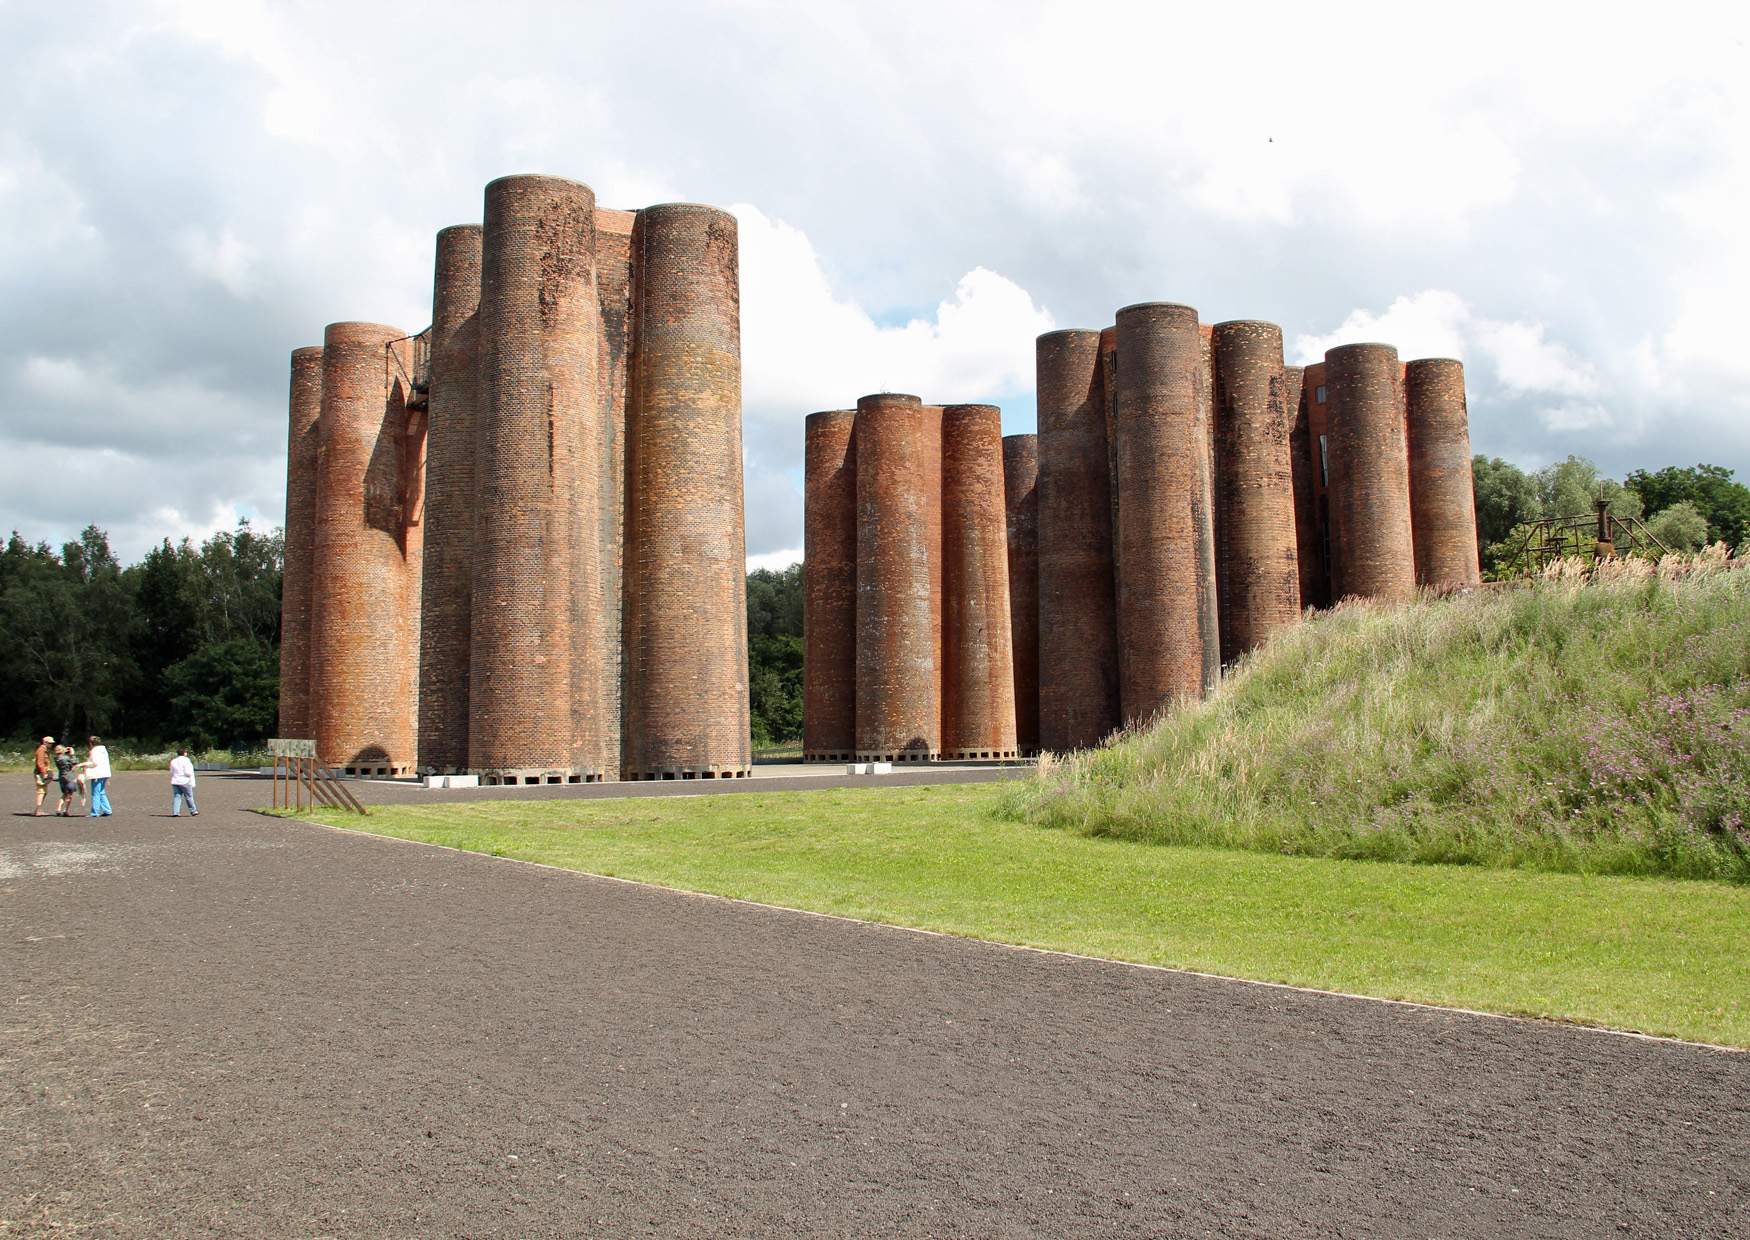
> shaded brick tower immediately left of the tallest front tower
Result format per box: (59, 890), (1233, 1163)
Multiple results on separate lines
(420, 224), (480, 773)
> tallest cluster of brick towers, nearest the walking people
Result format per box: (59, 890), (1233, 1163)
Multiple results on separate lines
(280, 177), (751, 784)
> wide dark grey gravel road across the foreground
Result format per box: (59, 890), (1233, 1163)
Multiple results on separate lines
(0, 775), (1750, 1237)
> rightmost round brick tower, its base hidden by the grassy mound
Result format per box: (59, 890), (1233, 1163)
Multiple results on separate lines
(1404, 357), (1482, 589)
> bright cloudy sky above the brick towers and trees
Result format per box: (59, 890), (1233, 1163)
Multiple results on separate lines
(0, 0), (1750, 563)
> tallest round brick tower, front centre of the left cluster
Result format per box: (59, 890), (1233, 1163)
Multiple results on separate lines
(469, 177), (606, 784)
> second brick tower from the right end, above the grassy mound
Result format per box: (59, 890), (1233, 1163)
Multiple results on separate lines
(1325, 345), (1416, 602)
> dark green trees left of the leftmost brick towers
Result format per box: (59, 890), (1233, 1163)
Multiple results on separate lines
(0, 521), (282, 745)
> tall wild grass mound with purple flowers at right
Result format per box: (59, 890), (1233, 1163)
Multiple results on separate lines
(1006, 554), (1750, 881)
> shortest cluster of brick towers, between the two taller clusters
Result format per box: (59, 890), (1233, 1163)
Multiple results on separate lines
(802, 402), (1019, 761)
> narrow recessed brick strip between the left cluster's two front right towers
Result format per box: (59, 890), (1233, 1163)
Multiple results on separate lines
(592, 206), (637, 778)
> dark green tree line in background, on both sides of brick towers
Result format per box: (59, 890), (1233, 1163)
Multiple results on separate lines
(0, 456), (1750, 749)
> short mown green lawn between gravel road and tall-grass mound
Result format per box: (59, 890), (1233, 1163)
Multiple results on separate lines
(297, 785), (1750, 1046)
